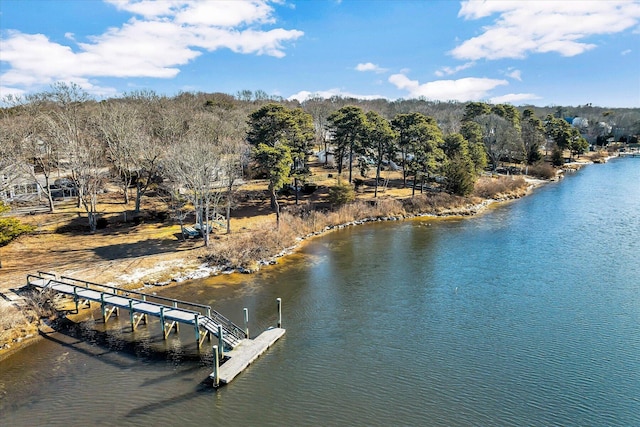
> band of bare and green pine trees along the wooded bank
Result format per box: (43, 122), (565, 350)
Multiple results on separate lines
(0, 83), (640, 237)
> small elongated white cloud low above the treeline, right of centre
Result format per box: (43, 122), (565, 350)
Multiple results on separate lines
(389, 74), (509, 102)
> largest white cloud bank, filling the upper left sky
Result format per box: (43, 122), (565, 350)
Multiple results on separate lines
(0, 0), (303, 91)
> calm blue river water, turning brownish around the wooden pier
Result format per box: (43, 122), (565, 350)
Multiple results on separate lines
(0, 159), (640, 426)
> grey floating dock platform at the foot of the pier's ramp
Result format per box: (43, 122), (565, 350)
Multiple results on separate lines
(210, 328), (285, 387)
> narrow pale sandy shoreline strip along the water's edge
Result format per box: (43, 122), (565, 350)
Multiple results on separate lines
(0, 162), (596, 363)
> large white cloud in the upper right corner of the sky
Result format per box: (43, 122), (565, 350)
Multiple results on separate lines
(450, 0), (640, 61)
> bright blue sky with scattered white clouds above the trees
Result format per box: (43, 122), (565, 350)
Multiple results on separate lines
(0, 0), (640, 107)
